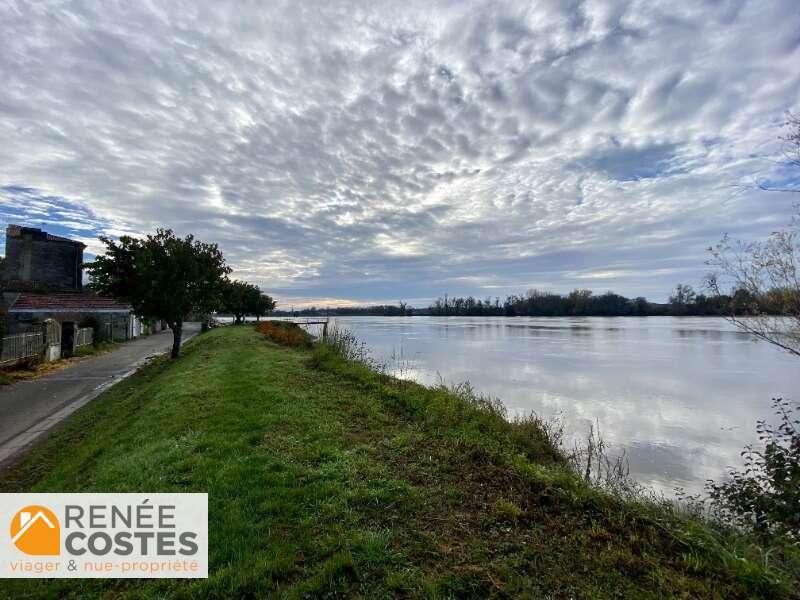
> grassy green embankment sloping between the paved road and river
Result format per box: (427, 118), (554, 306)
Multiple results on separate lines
(0, 326), (796, 598)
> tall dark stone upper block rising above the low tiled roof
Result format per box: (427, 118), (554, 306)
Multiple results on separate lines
(3, 225), (84, 291)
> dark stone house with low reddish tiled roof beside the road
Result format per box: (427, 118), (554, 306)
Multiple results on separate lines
(2, 225), (150, 354)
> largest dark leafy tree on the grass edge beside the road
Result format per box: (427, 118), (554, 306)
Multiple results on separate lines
(88, 229), (230, 358)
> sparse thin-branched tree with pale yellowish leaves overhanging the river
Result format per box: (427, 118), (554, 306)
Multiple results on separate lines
(706, 205), (800, 356)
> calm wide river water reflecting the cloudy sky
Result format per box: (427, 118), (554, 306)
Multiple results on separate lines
(298, 317), (800, 496)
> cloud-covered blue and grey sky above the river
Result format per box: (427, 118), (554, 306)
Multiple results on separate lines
(0, 0), (800, 308)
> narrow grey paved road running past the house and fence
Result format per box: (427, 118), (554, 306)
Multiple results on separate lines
(0, 323), (200, 463)
